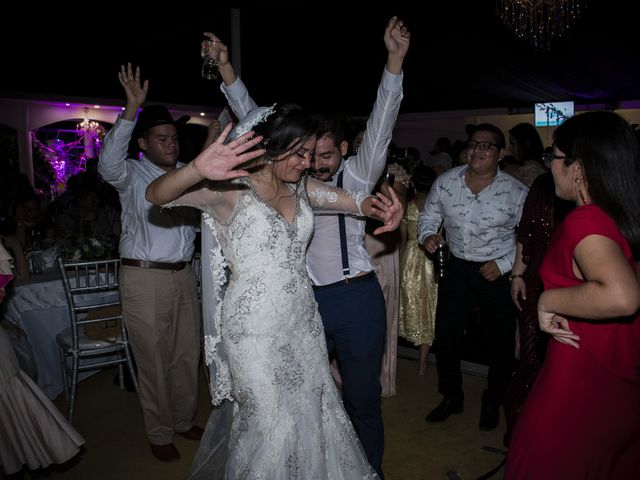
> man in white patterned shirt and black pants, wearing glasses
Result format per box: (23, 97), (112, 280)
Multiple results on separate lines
(418, 124), (527, 430)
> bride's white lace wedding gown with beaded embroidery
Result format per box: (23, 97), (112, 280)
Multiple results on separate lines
(182, 179), (378, 480)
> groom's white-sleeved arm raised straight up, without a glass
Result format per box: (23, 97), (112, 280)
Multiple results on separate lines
(349, 17), (410, 191)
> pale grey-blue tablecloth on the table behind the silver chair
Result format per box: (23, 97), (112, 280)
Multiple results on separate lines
(5, 270), (118, 399)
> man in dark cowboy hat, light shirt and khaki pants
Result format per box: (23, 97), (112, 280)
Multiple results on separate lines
(98, 64), (202, 462)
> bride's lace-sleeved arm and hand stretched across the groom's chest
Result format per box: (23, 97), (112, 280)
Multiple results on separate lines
(307, 178), (404, 235)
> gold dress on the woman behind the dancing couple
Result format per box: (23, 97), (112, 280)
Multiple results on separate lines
(398, 202), (438, 345)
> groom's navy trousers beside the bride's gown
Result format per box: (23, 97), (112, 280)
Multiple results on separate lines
(314, 272), (387, 475)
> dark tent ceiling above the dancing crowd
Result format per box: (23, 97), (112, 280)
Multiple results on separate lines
(0, 0), (640, 115)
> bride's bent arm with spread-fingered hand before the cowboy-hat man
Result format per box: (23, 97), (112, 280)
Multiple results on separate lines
(146, 124), (264, 206)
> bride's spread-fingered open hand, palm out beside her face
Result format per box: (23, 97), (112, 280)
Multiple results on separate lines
(193, 124), (265, 180)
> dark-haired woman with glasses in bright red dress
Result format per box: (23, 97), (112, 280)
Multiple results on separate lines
(505, 112), (640, 480)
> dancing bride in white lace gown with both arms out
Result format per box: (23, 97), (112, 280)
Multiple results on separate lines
(147, 105), (402, 480)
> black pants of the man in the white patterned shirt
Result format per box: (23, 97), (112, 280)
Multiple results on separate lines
(435, 256), (516, 405)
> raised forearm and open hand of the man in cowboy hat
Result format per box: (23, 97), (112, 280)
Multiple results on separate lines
(98, 63), (149, 189)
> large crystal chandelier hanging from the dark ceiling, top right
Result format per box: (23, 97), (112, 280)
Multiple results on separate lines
(497, 0), (583, 50)
